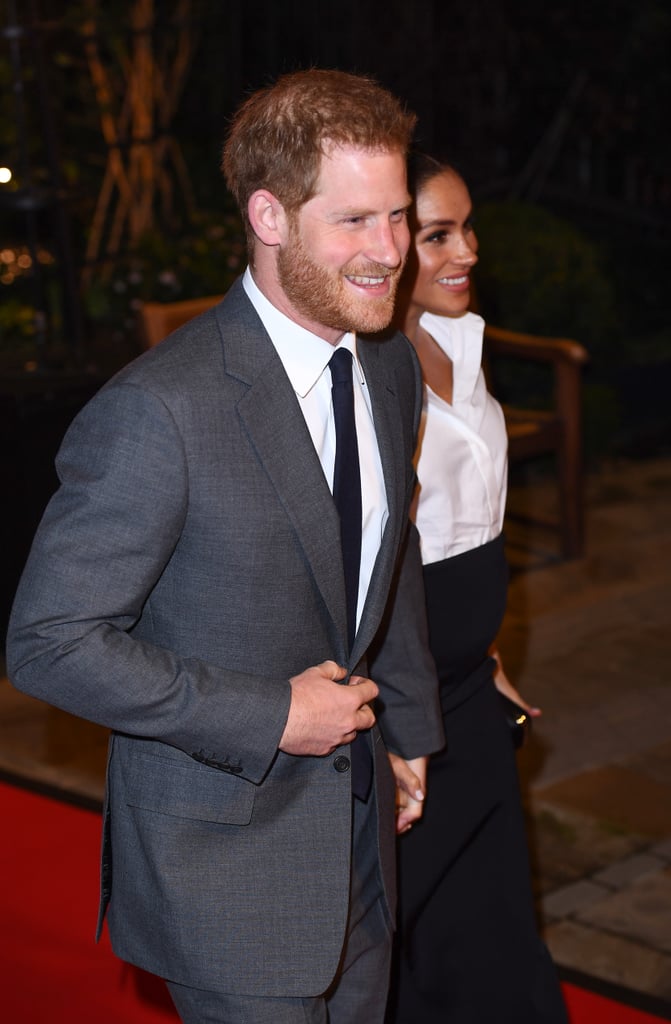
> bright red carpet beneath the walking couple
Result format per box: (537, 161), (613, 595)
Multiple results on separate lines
(0, 782), (668, 1024)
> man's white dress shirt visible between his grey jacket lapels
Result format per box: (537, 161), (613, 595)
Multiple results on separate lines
(243, 267), (389, 625)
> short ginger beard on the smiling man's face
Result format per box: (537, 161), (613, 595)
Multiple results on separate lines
(278, 229), (401, 334)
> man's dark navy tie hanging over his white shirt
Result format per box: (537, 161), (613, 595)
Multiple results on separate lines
(329, 348), (373, 800)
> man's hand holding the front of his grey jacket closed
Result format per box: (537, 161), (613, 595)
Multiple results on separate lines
(280, 662), (378, 757)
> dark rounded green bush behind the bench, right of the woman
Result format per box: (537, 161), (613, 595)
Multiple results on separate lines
(475, 201), (626, 457)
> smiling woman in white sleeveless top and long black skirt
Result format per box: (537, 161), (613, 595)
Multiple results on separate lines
(388, 156), (567, 1024)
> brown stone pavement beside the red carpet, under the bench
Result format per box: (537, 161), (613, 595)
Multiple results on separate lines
(0, 459), (671, 1007)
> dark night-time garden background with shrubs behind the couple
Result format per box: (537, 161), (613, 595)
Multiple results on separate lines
(0, 0), (671, 626)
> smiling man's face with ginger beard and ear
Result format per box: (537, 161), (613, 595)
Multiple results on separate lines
(268, 144), (409, 335)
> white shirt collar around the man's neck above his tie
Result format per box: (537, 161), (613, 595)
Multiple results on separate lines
(243, 267), (364, 398)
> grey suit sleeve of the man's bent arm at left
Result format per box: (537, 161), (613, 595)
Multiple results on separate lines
(7, 385), (291, 781)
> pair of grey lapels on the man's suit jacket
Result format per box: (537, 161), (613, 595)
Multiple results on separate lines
(217, 284), (408, 665)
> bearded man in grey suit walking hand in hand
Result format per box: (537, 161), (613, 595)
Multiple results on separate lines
(7, 70), (444, 1024)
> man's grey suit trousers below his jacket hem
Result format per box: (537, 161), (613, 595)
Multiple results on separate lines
(167, 799), (392, 1024)
